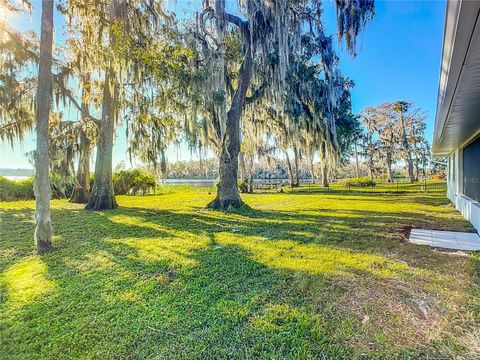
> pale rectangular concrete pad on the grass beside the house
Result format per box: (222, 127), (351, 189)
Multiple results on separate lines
(408, 229), (480, 251)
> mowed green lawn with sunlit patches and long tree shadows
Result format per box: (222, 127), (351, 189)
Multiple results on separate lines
(0, 187), (480, 359)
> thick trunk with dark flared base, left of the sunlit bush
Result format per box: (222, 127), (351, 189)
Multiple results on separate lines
(85, 70), (118, 210)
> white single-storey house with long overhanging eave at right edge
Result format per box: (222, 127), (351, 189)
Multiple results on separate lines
(432, 0), (480, 230)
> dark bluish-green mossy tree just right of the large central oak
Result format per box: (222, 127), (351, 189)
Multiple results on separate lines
(251, 32), (354, 187)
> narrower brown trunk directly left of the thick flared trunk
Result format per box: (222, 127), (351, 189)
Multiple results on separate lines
(70, 75), (92, 204)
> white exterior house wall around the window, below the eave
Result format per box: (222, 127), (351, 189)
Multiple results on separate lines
(447, 136), (480, 232)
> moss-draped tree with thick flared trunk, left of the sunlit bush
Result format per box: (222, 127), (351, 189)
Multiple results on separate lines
(62, 0), (163, 210)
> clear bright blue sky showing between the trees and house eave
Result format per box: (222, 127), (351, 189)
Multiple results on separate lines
(0, 0), (446, 168)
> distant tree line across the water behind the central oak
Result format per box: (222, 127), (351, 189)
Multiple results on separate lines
(153, 101), (432, 187)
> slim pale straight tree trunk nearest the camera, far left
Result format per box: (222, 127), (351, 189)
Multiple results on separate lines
(34, 0), (53, 253)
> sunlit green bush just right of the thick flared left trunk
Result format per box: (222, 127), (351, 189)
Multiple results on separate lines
(113, 170), (156, 195)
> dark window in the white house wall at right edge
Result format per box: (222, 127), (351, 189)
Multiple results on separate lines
(463, 138), (480, 202)
